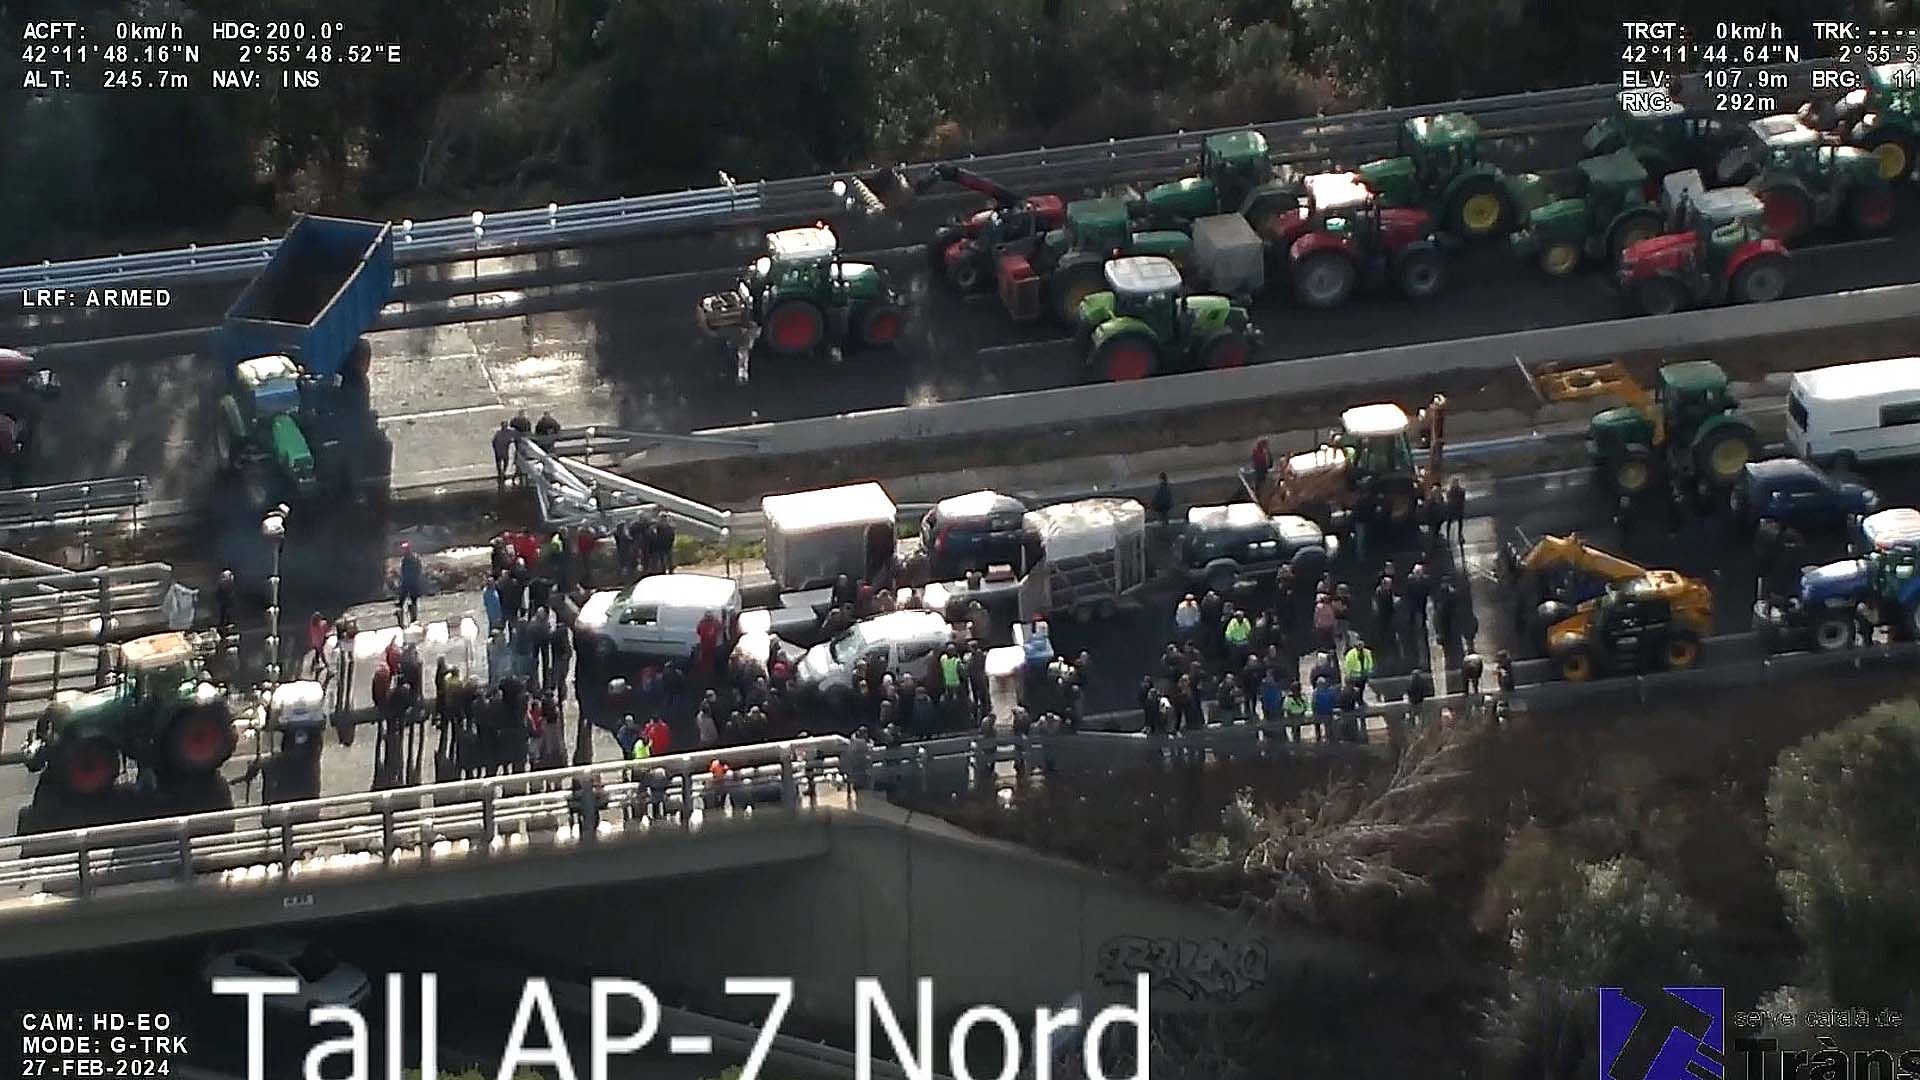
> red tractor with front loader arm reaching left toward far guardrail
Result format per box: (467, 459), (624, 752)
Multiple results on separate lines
(852, 163), (1068, 292)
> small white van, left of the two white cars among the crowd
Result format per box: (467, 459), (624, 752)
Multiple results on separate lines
(576, 575), (741, 659)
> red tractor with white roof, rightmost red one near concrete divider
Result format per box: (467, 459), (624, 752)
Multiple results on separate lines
(1615, 171), (1793, 315)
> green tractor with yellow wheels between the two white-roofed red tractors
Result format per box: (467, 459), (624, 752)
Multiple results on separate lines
(1509, 150), (1663, 277)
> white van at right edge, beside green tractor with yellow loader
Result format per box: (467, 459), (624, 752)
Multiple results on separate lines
(1788, 356), (1920, 467)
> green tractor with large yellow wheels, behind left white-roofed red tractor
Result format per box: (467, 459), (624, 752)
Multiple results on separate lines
(1357, 113), (1546, 240)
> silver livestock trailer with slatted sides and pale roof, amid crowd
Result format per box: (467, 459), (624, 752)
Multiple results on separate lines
(1020, 498), (1146, 621)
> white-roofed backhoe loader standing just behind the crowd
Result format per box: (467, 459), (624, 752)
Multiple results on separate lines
(1240, 394), (1446, 530)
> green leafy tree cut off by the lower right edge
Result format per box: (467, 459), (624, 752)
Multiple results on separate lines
(1766, 700), (1920, 1011)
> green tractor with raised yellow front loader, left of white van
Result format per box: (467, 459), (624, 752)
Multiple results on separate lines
(1521, 359), (1761, 496)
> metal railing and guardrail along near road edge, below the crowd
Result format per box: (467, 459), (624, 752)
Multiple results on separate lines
(0, 634), (1920, 897)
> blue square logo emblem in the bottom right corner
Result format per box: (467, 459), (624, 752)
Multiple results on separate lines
(1599, 986), (1726, 1080)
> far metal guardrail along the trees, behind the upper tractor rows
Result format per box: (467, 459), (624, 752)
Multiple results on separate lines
(0, 63), (1816, 290)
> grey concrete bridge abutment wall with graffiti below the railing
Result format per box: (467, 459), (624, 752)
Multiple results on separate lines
(459, 807), (1384, 1032)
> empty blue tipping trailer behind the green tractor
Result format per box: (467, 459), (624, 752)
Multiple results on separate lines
(221, 213), (394, 380)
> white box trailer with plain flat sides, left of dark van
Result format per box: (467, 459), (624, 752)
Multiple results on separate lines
(760, 482), (899, 590)
